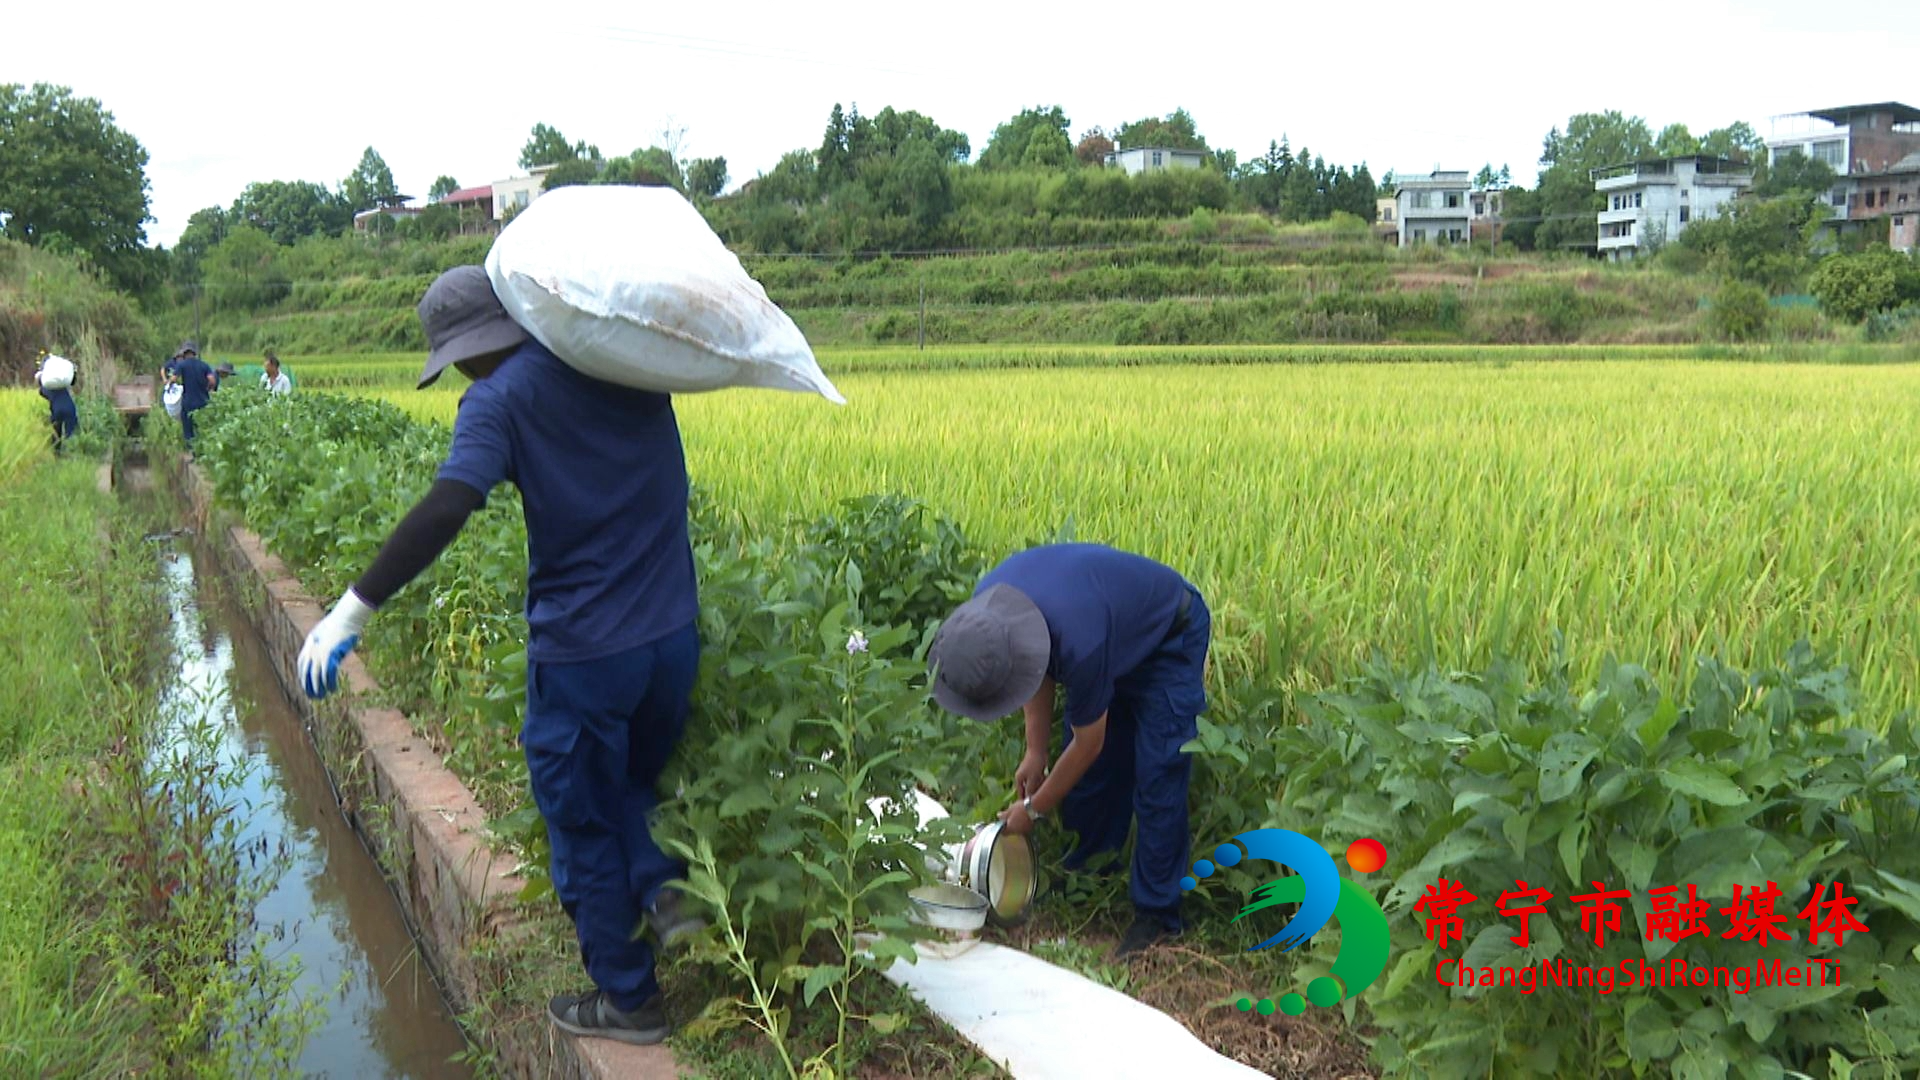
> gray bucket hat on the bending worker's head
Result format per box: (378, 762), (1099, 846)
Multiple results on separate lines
(927, 584), (1052, 723)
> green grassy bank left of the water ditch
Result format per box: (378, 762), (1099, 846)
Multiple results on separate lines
(0, 390), (311, 1076)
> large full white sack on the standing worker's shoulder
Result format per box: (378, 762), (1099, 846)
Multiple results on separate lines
(486, 184), (847, 405)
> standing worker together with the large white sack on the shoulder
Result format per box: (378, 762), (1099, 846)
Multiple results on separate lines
(300, 197), (841, 1043)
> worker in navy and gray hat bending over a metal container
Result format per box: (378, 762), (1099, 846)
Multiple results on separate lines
(927, 544), (1212, 957)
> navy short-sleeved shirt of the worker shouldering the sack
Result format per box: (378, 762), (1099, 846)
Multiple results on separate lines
(440, 340), (699, 663)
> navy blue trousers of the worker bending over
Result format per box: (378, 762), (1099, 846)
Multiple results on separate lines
(1060, 590), (1213, 930)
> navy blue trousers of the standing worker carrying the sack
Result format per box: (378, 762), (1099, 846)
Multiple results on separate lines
(520, 623), (701, 1011)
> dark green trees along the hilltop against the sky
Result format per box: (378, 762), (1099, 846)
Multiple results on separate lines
(0, 85), (1912, 328)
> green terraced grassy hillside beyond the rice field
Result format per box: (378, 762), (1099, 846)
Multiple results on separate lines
(161, 219), (1797, 356)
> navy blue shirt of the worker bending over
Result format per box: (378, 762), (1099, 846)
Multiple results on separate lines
(973, 544), (1190, 726)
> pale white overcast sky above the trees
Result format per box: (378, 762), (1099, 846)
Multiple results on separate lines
(15, 0), (1920, 246)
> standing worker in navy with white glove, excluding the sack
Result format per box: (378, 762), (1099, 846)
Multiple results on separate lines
(300, 265), (703, 1043)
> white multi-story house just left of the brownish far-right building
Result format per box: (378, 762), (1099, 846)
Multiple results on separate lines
(1592, 156), (1753, 259)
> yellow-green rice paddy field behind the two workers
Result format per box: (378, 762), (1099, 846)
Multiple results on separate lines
(290, 350), (1920, 726)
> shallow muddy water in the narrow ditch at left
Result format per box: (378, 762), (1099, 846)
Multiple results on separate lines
(156, 536), (472, 1080)
